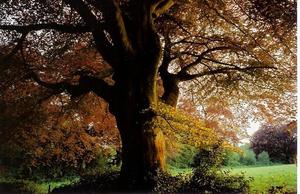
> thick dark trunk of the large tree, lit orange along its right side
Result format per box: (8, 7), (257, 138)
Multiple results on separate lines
(105, 6), (165, 189)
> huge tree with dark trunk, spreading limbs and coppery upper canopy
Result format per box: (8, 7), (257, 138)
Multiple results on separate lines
(0, 0), (295, 187)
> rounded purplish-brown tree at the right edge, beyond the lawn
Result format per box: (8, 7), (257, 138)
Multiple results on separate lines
(251, 121), (297, 163)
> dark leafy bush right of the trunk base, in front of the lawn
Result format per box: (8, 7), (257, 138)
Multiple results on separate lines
(181, 144), (251, 193)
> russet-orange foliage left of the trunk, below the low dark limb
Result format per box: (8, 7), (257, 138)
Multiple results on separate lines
(0, 83), (120, 178)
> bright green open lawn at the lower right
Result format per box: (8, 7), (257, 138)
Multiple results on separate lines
(232, 164), (297, 193)
